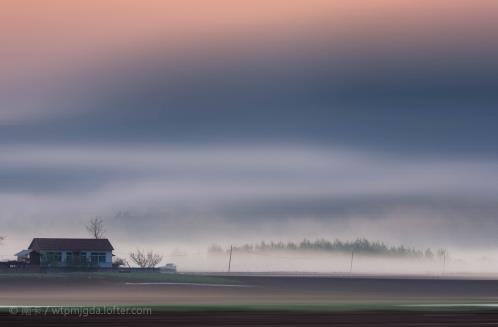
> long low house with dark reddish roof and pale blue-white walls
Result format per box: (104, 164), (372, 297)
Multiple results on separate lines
(16, 238), (114, 268)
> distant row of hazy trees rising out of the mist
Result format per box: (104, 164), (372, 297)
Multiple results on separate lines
(208, 238), (447, 259)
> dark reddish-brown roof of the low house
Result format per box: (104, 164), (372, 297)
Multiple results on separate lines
(28, 238), (114, 251)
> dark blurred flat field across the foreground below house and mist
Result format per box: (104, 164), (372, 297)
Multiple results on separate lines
(0, 273), (498, 326)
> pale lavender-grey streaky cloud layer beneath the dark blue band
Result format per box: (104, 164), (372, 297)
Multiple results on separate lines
(0, 145), (498, 258)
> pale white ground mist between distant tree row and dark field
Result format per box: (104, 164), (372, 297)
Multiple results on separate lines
(110, 244), (498, 276)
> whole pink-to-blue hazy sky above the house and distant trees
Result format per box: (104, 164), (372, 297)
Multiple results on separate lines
(0, 0), (498, 266)
